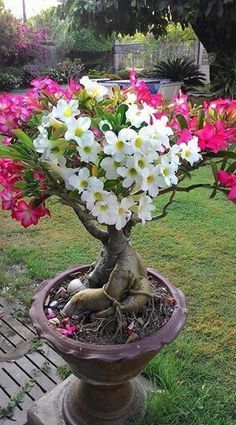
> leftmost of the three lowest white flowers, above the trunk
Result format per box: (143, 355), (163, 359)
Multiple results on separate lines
(91, 194), (118, 225)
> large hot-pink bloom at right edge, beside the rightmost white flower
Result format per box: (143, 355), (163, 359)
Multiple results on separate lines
(196, 120), (234, 153)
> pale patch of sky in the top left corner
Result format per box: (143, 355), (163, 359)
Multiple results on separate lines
(4, 0), (58, 18)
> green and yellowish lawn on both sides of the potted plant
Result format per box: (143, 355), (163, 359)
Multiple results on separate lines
(0, 169), (236, 425)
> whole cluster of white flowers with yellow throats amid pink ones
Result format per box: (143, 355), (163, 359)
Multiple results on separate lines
(34, 77), (201, 230)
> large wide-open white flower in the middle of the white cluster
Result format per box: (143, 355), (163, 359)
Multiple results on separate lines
(104, 128), (136, 162)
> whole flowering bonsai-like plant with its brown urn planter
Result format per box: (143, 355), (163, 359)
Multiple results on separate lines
(0, 73), (236, 425)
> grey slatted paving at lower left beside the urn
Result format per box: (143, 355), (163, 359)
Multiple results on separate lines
(0, 297), (64, 425)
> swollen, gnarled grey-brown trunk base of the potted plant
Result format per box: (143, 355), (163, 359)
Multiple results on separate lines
(63, 226), (151, 317)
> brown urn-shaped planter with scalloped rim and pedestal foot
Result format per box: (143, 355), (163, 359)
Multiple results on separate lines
(30, 265), (187, 425)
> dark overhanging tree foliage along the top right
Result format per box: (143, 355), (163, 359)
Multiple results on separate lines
(61, 0), (236, 78)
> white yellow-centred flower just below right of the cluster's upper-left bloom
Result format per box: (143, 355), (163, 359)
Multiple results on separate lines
(65, 117), (94, 143)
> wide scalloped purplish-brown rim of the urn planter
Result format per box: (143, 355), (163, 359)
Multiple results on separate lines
(29, 265), (187, 361)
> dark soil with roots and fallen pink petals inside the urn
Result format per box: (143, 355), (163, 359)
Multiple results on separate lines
(44, 272), (175, 345)
